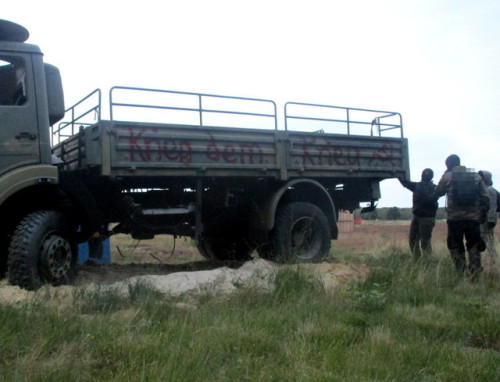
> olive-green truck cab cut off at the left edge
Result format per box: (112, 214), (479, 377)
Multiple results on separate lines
(0, 20), (73, 286)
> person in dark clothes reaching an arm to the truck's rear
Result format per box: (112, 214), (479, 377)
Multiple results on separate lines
(399, 168), (438, 260)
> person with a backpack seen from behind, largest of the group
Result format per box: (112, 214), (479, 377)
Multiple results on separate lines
(436, 154), (489, 281)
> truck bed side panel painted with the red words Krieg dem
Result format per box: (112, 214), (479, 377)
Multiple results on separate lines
(109, 122), (282, 176)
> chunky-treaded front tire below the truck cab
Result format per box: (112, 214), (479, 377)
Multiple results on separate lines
(8, 211), (77, 290)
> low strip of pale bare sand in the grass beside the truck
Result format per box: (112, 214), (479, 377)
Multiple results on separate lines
(0, 259), (369, 303)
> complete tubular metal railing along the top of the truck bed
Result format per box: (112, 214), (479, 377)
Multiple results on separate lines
(52, 86), (403, 144)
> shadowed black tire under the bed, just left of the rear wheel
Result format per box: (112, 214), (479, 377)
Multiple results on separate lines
(196, 237), (254, 261)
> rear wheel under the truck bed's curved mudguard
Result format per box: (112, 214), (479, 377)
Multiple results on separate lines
(267, 202), (331, 263)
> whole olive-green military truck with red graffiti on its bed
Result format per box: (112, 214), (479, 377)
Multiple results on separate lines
(0, 21), (409, 289)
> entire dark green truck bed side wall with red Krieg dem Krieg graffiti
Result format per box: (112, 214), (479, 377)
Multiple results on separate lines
(54, 121), (408, 180)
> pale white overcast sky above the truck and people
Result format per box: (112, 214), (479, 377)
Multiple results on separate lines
(0, 0), (500, 207)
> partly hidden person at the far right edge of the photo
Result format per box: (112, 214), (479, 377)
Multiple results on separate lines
(478, 170), (498, 273)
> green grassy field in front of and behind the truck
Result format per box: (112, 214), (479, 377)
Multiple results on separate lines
(0, 224), (500, 381)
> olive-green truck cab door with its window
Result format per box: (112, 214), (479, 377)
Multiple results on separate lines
(0, 54), (40, 175)
